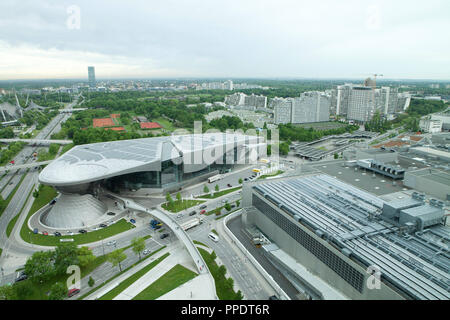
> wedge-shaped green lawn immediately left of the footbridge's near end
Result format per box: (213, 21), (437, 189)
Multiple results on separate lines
(133, 264), (197, 300)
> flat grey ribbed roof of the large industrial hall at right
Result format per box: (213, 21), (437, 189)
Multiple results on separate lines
(253, 174), (450, 300)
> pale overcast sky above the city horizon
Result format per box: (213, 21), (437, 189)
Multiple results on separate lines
(0, 0), (450, 80)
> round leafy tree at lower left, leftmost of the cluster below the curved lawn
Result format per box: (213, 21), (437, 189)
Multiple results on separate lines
(24, 251), (55, 282)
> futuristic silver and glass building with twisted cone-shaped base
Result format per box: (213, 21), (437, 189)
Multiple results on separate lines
(39, 133), (266, 228)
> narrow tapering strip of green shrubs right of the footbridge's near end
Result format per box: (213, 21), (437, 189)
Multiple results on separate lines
(198, 248), (242, 300)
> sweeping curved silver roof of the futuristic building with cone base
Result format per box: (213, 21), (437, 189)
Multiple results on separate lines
(39, 133), (264, 186)
